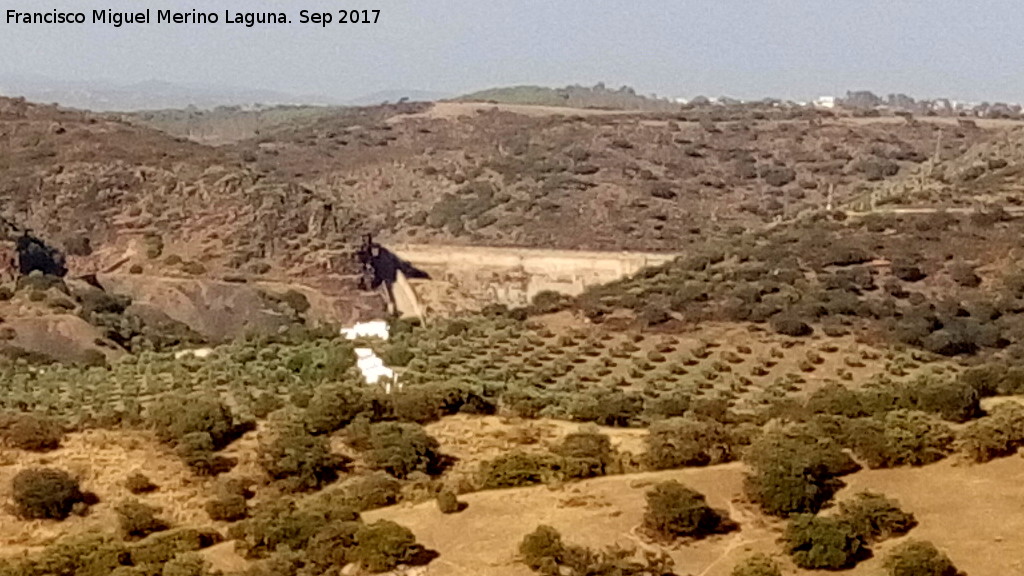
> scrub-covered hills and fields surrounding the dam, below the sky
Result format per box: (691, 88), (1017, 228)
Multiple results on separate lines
(0, 89), (1024, 576)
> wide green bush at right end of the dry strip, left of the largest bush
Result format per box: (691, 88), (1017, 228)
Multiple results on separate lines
(644, 416), (732, 470)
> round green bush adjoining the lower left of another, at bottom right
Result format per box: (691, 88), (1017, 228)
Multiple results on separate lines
(782, 515), (867, 570)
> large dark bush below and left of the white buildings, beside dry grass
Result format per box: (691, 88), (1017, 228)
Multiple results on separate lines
(257, 423), (347, 491)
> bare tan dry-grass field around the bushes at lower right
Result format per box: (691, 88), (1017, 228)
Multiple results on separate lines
(367, 457), (1024, 576)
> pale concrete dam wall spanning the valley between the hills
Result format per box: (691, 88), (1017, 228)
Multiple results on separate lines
(390, 244), (678, 314)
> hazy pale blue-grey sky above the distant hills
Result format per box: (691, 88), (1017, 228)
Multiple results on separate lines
(0, 0), (1024, 101)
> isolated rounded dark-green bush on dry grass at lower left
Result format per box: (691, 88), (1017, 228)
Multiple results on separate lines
(11, 468), (85, 520)
